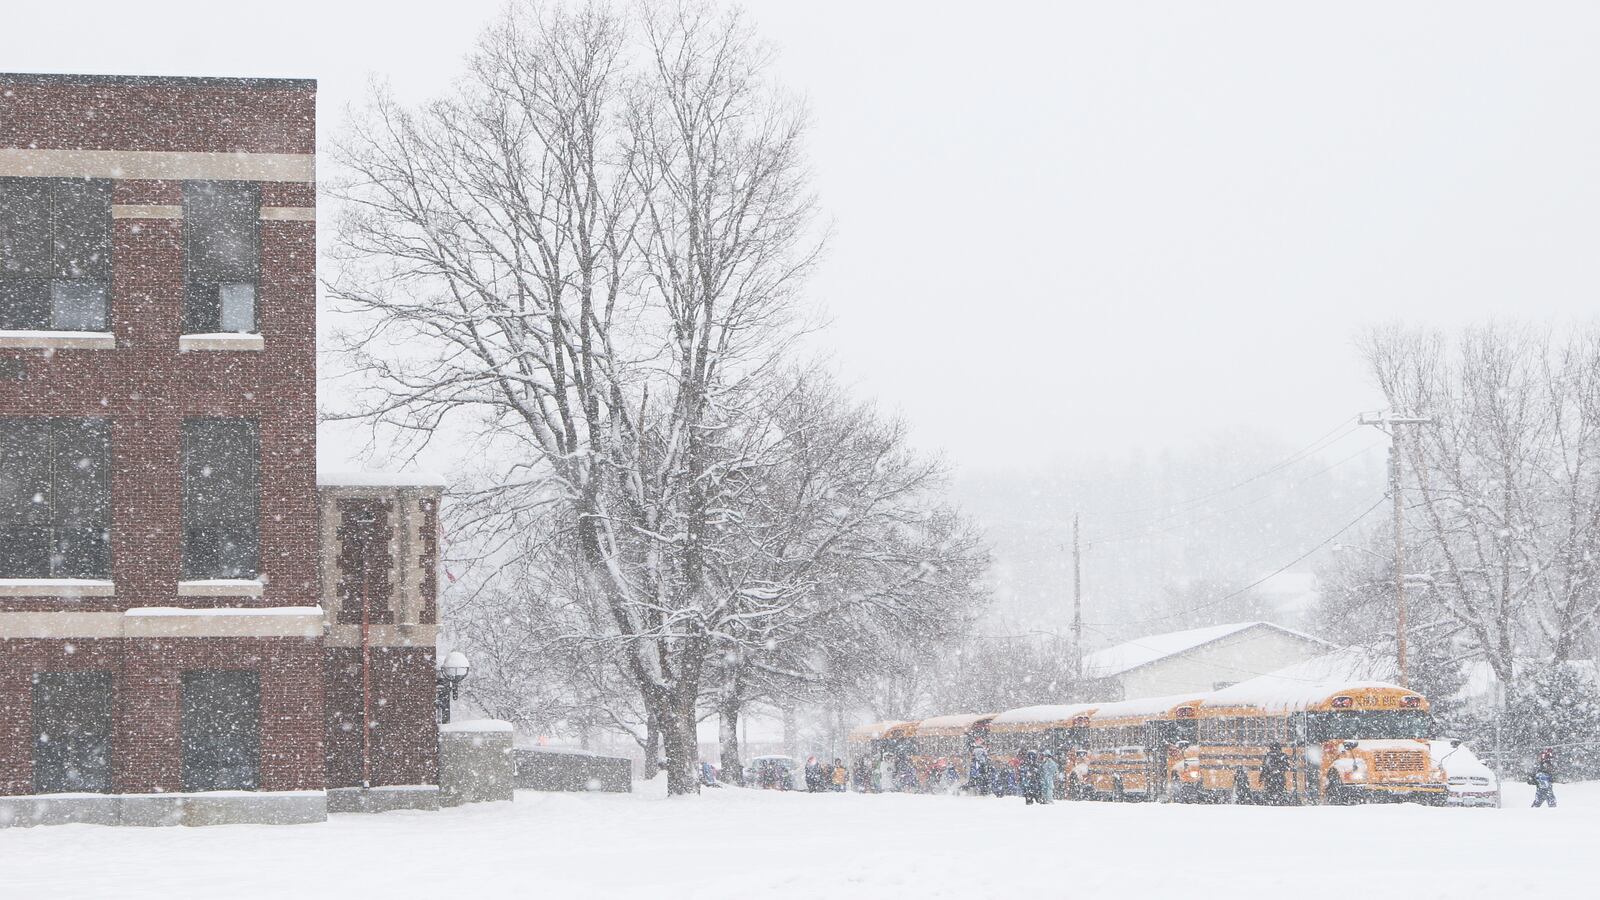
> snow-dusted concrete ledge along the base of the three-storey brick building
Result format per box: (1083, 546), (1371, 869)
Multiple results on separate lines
(0, 791), (328, 828)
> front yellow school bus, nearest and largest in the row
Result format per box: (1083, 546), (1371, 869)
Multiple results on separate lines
(1173, 679), (1448, 804)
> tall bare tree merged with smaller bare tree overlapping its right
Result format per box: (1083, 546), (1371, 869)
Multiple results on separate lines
(330, 5), (981, 793)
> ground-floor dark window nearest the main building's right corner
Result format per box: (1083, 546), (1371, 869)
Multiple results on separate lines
(181, 671), (261, 791)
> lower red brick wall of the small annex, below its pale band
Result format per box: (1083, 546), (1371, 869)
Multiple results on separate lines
(326, 647), (438, 788)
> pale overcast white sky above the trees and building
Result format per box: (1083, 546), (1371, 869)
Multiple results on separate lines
(0, 0), (1600, 472)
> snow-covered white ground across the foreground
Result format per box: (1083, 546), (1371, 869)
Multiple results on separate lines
(0, 783), (1600, 900)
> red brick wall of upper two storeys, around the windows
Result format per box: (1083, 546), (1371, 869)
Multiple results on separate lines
(0, 75), (320, 610)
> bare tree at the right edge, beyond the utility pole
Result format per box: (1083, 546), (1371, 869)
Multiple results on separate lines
(1363, 325), (1600, 701)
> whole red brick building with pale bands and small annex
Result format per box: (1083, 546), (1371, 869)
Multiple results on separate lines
(0, 74), (440, 822)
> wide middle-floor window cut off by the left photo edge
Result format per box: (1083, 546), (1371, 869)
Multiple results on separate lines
(0, 418), (110, 578)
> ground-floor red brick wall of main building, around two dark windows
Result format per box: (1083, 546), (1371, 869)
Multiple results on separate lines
(0, 637), (325, 794)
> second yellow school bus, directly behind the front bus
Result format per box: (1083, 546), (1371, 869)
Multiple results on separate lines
(1067, 693), (1202, 802)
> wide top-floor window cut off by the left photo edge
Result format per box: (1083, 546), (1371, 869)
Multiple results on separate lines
(0, 178), (110, 331)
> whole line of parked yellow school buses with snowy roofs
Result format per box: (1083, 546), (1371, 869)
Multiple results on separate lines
(850, 677), (1448, 806)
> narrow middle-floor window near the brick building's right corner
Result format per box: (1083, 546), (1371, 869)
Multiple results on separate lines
(182, 418), (261, 580)
